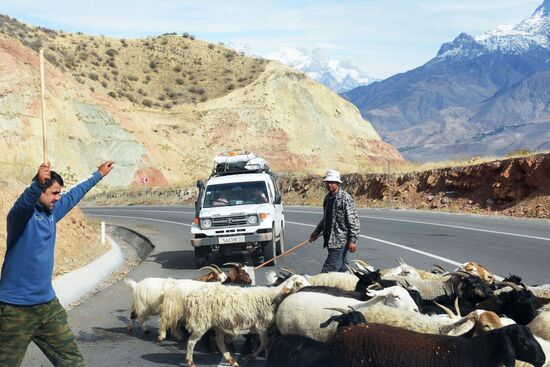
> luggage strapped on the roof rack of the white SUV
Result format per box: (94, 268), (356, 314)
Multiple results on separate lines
(212, 152), (270, 176)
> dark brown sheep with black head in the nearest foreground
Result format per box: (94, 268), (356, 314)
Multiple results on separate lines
(327, 323), (545, 367)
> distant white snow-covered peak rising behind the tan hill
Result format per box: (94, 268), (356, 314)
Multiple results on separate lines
(265, 47), (376, 93)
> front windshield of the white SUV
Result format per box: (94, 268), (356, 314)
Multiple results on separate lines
(203, 181), (269, 208)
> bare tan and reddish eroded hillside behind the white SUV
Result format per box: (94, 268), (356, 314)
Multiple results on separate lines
(0, 25), (403, 188)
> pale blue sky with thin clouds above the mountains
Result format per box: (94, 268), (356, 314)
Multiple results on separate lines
(0, 0), (543, 78)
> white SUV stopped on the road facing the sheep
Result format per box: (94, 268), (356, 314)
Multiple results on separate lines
(191, 155), (285, 267)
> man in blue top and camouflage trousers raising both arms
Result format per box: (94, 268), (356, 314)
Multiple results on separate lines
(0, 162), (114, 367)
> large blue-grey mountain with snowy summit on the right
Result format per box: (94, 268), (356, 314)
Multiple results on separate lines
(344, 0), (550, 160)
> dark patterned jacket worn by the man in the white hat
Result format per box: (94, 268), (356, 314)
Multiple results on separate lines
(315, 188), (359, 248)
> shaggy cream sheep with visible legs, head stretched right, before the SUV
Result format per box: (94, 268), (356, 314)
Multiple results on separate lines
(183, 275), (310, 367)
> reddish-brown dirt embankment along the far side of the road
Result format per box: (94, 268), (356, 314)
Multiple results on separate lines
(279, 154), (550, 218)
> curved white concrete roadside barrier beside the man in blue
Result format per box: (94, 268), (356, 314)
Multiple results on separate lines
(53, 236), (124, 307)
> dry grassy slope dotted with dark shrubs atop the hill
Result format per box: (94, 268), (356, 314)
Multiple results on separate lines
(0, 15), (266, 109)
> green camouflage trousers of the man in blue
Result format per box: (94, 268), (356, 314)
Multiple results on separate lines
(0, 298), (84, 367)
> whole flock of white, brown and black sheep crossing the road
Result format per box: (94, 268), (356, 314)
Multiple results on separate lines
(126, 260), (550, 367)
